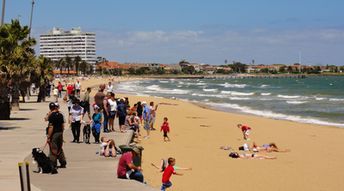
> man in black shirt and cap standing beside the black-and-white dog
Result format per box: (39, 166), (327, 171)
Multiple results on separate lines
(47, 102), (67, 168)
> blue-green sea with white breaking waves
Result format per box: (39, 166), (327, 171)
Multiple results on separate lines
(117, 76), (344, 127)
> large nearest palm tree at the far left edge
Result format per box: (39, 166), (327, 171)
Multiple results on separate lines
(0, 20), (36, 112)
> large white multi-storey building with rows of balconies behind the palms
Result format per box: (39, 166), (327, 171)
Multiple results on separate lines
(39, 27), (96, 64)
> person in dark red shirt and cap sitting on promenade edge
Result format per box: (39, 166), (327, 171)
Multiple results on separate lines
(117, 147), (144, 183)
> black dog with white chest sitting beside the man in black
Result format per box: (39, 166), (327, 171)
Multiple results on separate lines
(32, 148), (57, 174)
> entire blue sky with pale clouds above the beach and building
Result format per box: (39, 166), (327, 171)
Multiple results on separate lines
(5, 0), (344, 65)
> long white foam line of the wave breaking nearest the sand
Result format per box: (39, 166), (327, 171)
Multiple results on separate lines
(208, 103), (344, 127)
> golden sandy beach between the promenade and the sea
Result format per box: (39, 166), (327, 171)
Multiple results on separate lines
(100, 78), (344, 191)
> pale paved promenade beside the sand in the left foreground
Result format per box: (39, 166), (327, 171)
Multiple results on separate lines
(0, 97), (155, 191)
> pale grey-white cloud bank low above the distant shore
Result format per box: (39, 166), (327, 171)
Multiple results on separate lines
(47, 28), (344, 65)
